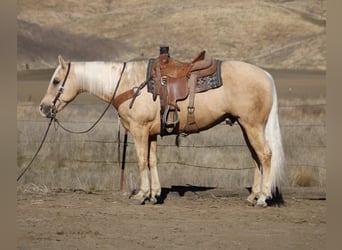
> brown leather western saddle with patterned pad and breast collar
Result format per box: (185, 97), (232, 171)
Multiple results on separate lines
(114, 46), (222, 136)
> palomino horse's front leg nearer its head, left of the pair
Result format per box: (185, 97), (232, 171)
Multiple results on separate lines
(131, 127), (150, 204)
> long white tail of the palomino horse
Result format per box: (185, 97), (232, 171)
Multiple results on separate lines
(265, 71), (286, 193)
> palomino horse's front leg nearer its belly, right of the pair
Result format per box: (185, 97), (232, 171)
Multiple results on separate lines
(149, 136), (161, 203)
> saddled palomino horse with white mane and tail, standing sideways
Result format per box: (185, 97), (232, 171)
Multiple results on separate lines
(39, 56), (285, 207)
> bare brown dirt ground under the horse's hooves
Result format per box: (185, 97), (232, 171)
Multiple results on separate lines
(17, 186), (327, 249)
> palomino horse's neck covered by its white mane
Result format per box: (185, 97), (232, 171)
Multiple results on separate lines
(75, 62), (123, 102)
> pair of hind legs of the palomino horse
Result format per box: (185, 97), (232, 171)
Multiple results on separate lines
(242, 122), (272, 207)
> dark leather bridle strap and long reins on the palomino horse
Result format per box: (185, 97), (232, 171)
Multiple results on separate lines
(17, 62), (126, 182)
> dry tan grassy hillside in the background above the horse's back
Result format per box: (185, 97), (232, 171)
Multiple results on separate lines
(17, 0), (326, 70)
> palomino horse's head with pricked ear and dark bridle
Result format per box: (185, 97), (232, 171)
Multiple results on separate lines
(39, 56), (79, 118)
